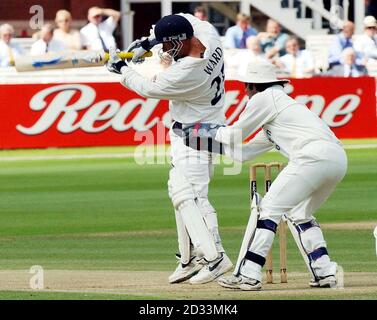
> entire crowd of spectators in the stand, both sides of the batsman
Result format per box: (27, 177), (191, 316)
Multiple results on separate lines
(0, 6), (377, 78)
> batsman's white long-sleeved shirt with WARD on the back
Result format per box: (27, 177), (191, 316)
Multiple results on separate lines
(121, 14), (225, 124)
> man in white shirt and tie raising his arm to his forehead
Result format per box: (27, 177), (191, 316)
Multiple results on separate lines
(80, 7), (120, 51)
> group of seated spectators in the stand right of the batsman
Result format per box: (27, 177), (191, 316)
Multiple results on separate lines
(219, 10), (377, 78)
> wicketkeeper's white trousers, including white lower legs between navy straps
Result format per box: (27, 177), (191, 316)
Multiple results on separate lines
(241, 141), (347, 280)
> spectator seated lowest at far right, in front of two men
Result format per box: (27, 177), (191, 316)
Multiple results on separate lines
(325, 47), (368, 78)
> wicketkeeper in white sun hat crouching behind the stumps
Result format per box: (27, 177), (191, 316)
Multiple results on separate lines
(185, 63), (347, 290)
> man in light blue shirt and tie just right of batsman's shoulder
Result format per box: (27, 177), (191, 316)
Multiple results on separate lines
(224, 13), (257, 49)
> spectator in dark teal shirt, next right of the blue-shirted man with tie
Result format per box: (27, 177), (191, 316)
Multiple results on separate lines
(258, 19), (289, 60)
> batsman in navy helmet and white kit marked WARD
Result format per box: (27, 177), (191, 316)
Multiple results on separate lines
(107, 14), (232, 284)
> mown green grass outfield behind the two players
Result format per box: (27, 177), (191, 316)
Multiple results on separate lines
(0, 139), (377, 299)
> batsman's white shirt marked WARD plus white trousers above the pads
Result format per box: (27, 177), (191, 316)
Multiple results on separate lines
(121, 14), (225, 207)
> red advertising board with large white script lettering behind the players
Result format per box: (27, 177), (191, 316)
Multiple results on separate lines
(0, 78), (377, 149)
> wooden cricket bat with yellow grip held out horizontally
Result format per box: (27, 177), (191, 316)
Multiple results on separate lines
(15, 50), (152, 72)
